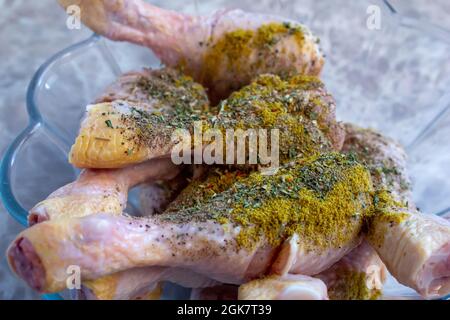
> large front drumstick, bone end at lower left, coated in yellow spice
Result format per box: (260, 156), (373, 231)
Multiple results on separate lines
(8, 153), (372, 292)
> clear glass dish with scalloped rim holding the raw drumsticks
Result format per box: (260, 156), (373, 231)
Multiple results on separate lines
(0, 0), (450, 299)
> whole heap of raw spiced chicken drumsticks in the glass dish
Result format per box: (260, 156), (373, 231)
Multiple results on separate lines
(4, 0), (450, 299)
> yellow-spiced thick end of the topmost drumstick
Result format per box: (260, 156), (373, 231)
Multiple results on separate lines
(195, 22), (323, 99)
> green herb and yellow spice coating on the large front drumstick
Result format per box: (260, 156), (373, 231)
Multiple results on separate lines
(167, 153), (374, 248)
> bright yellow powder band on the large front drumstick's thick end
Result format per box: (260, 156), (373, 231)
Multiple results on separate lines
(232, 166), (371, 248)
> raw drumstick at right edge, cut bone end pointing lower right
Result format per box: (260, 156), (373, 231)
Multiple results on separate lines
(343, 124), (450, 298)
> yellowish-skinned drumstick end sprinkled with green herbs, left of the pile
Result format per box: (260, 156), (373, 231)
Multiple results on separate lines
(69, 69), (209, 168)
